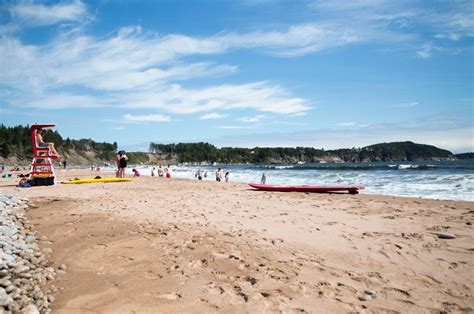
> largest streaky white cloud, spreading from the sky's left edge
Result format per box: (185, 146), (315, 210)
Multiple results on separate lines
(0, 23), (310, 114)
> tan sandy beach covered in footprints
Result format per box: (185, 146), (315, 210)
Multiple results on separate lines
(0, 171), (474, 313)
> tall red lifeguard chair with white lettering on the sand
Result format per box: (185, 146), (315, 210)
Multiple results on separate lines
(30, 124), (59, 185)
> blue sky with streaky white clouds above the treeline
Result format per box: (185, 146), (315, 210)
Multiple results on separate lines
(0, 0), (474, 152)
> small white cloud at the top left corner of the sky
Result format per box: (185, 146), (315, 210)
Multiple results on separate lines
(9, 0), (88, 26)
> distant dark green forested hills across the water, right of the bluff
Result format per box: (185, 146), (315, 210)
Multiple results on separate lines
(150, 142), (456, 163)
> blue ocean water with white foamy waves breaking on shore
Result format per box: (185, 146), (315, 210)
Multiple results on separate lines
(107, 160), (474, 201)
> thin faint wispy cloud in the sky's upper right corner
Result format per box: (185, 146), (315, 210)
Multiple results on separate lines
(310, 0), (474, 59)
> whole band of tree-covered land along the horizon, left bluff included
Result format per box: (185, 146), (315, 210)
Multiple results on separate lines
(0, 125), (464, 165)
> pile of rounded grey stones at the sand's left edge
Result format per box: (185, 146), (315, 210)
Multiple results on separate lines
(0, 194), (57, 314)
